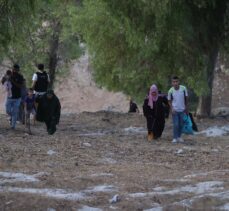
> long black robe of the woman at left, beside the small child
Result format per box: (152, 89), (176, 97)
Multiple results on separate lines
(36, 94), (61, 135)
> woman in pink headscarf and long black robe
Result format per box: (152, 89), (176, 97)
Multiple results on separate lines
(143, 84), (168, 141)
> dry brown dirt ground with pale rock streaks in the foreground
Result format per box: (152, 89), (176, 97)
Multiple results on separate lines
(0, 111), (229, 211)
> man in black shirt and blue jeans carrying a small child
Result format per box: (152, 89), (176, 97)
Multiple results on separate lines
(6, 64), (24, 129)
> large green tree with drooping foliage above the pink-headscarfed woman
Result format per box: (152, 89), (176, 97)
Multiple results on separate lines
(74, 0), (228, 115)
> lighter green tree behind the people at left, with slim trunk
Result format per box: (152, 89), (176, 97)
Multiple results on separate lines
(1, 0), (82, 88)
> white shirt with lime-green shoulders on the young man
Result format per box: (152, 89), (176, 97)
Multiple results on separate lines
(168, 85), (188, 112)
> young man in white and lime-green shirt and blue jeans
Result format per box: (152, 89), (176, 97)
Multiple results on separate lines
(168, 76), (188, 143)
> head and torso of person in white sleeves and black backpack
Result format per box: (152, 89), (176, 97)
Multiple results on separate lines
(32, 64), (50, 96)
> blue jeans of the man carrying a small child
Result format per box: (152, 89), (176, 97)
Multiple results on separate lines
(6, 98), (21, 128)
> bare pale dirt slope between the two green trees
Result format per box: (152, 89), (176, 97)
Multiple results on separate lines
(55, 54), (129, 113)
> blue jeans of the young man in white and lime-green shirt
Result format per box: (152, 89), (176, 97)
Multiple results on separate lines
(172, 112), (184, 139)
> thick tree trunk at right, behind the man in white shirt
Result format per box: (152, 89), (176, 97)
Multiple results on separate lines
(196, 47), (219, 118)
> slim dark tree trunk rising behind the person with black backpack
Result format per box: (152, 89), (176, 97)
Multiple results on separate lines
(49, 22), (61, 89)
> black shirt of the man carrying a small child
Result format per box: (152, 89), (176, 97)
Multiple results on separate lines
(10, 73), (24, 99)
